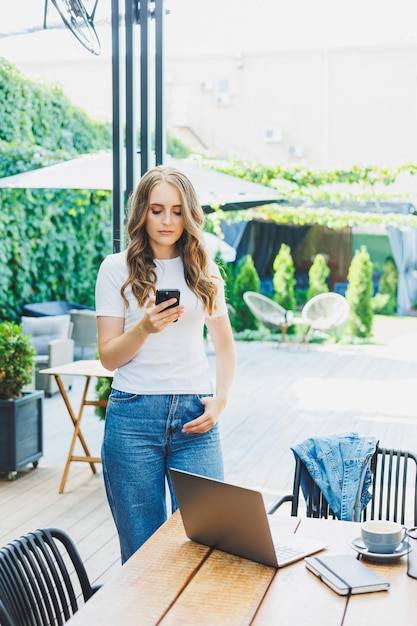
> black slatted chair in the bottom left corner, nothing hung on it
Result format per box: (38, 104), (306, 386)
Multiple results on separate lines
(0, 528), (99, 626)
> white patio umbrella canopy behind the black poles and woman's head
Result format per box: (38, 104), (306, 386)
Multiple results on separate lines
(0, 151), (278, 211)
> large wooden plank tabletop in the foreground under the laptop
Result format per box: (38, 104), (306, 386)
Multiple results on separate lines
(65, 512), (417, 626)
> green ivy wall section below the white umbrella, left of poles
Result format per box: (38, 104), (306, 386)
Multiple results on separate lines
(0, 189), (112, 321)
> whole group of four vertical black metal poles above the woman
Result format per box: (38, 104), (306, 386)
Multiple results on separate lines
(112, 0), (166, 252)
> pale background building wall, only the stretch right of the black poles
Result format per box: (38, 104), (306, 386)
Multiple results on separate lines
(166, 46), (417, 168)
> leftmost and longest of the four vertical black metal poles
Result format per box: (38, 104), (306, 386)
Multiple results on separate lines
(111, 0), (124, 252)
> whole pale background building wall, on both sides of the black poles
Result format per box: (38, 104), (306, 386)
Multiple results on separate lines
(4, 23), (417, 168)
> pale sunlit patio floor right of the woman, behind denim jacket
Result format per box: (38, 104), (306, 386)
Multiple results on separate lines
(218, 335), (417, 492)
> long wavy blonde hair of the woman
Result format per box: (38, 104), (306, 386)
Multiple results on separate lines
(120, 165), (219, 315)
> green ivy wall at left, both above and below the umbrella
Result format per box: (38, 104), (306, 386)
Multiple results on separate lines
(0, 57), (112, 321)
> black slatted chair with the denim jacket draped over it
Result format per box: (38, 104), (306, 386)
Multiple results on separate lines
(268, 447), (417, 526)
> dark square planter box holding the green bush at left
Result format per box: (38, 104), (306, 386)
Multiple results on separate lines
(0, 391), (44, 479)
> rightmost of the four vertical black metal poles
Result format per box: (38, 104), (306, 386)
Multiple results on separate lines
(155, 0), (166, 165)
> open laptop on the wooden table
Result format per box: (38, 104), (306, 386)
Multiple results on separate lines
(170, 468), (327, 567)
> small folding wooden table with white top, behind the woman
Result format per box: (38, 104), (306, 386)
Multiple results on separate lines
(40, 360), (113, 493)
